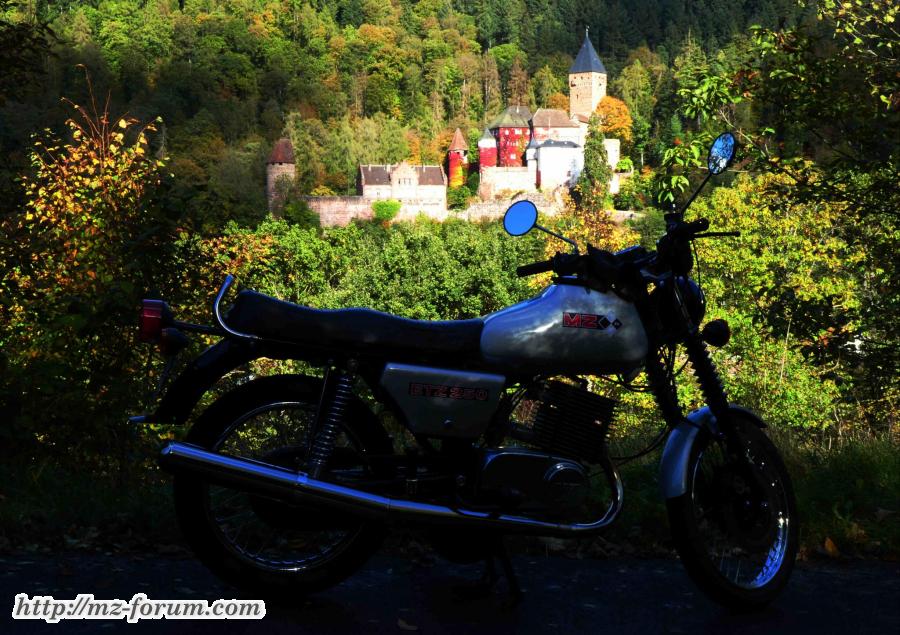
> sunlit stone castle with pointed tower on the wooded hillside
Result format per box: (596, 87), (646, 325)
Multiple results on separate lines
(266, 31), (623, 225)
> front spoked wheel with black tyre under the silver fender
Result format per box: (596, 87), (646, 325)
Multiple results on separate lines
(668, 413), (798, 610)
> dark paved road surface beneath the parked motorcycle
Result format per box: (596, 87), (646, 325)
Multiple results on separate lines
(0, 553), (900, 635)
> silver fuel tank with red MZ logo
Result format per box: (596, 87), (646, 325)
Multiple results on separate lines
(481, 284), (647, 374)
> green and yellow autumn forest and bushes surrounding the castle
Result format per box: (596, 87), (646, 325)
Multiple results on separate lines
(0, 0), (900, 553)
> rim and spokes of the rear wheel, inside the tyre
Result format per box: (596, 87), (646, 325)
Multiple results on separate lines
(203, 402), (367, 571)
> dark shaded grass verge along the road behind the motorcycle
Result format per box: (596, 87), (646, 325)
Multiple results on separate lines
(0, 430), (900, 559)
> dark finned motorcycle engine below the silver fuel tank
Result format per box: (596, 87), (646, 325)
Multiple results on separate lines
(476, 381), (616, 519)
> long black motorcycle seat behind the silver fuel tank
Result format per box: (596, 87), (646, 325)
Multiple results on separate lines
(225, 291), (484, 357)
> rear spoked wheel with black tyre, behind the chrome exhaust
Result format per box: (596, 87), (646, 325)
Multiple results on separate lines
(175, 376), (390, 597)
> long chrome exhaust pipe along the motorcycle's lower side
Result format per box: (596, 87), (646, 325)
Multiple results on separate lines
(159, 442), (623, 538)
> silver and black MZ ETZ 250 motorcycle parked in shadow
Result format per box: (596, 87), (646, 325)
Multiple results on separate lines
(135, 133), (798, 610)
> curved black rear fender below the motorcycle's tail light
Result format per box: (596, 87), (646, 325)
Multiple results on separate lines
(148, 339), (264, 425)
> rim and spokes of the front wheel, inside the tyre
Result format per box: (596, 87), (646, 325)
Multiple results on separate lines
(691, 428), (792, 589)
